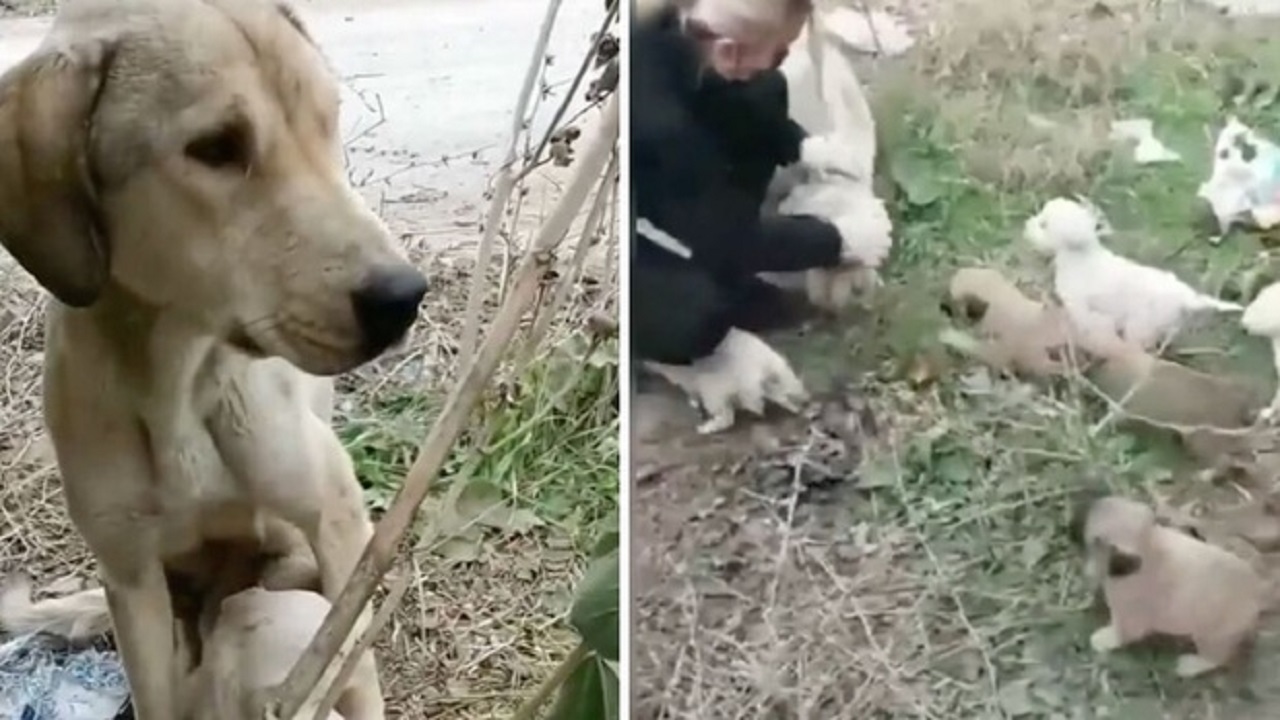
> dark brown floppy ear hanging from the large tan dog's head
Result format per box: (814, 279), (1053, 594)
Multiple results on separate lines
(0, 41), (114, 307)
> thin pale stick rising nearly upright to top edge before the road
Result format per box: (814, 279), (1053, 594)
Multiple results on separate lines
(458, 0), (561, 368)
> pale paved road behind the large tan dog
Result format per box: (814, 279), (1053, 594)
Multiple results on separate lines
(0, 0), (604, 211)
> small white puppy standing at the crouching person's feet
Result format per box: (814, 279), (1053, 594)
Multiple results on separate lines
(645, 328), (808, 434)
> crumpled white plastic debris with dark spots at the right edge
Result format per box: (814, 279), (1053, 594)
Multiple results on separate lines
(1196, 117), (1280, 234)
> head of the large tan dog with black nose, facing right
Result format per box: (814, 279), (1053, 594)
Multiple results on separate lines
(0, 0), (426, 374)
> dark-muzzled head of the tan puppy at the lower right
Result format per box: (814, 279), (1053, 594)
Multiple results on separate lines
(1083, 496), (1156, 579)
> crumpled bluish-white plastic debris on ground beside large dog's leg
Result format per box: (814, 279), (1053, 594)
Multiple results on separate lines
(0, 635), (129, 720)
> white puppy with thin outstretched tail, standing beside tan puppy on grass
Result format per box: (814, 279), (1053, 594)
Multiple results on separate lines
(1023, 197), (1244, 348)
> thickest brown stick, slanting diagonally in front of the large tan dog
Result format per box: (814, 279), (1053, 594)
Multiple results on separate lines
(266, 97), (618, 720)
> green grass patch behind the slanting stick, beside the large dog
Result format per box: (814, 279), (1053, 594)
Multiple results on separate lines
(338, 334), (618, 548)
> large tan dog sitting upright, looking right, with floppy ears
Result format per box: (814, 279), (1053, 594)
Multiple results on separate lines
(0, 0), (426, 720)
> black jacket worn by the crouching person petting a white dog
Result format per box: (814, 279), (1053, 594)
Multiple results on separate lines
(630, 4), (841, 281)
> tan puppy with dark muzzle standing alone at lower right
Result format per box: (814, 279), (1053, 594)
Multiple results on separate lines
(1084, 496), (1267, 678)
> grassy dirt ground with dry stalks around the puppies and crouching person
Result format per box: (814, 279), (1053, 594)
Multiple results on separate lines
(631, 0), (1280, 720)
